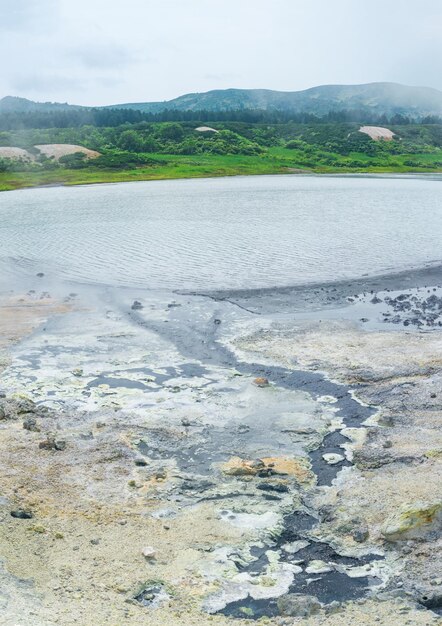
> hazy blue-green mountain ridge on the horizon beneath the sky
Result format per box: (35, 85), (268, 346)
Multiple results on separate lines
(0, 83), (442, 117)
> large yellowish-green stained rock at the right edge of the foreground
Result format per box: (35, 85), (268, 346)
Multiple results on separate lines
(381, 501), (442, 541)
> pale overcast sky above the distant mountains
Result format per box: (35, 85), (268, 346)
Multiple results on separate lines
(0, 0), (442, 105)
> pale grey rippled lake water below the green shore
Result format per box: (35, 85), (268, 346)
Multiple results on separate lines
(0, 176), (442, 289)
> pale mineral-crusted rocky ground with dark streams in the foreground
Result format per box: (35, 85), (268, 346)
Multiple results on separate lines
(0, 281), (442, 626)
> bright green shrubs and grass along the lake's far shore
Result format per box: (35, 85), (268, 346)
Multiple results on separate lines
(0, 120), (442, 190)
